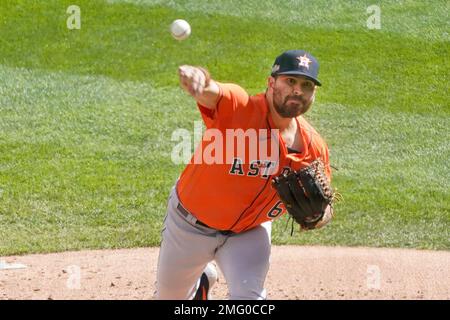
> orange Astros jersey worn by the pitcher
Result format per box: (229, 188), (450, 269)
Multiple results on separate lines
(177, 83), (331, 233)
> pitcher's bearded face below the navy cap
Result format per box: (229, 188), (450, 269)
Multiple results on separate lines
(273, 75), (315, 118)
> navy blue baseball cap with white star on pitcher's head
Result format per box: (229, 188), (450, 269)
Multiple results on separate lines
(271, 50), (322, 86)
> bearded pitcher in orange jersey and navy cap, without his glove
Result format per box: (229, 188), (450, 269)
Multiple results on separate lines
(156, 50), (332, 300)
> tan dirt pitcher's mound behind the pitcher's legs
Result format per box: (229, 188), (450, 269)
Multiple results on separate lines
(0, 246), (450, 299)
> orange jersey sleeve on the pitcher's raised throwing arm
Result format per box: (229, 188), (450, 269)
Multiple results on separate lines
(197, 82), (249, 128)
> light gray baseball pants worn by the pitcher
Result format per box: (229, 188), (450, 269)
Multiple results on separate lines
(156, 187), (272, 300)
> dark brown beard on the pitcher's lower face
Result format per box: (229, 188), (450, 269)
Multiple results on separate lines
(272, 89), (314, 118)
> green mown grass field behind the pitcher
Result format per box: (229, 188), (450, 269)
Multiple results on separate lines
(0, 0), (450, 255)
